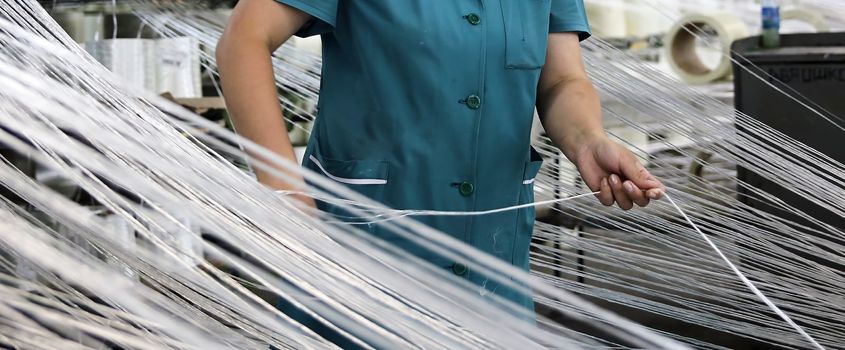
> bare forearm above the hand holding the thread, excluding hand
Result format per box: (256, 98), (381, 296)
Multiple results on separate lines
(537, 77), (605, 161)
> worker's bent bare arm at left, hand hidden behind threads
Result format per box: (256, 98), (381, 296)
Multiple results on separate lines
(216, 0), (313, 205)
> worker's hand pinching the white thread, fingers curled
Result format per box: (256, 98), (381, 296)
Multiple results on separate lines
(573, 135), (665, 210)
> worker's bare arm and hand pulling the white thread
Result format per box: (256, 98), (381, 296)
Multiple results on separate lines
(537, 33), (663, 210)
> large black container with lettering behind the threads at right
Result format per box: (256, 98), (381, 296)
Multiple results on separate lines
(733, 33), (845, 239)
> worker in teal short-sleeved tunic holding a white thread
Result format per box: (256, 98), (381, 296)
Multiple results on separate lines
(217, 0), (663, 344)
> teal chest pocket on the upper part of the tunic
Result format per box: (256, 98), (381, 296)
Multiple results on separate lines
(502, 0), (551, 69)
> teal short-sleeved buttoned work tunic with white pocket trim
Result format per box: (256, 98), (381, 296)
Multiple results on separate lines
(277, 0), (589, 308)
